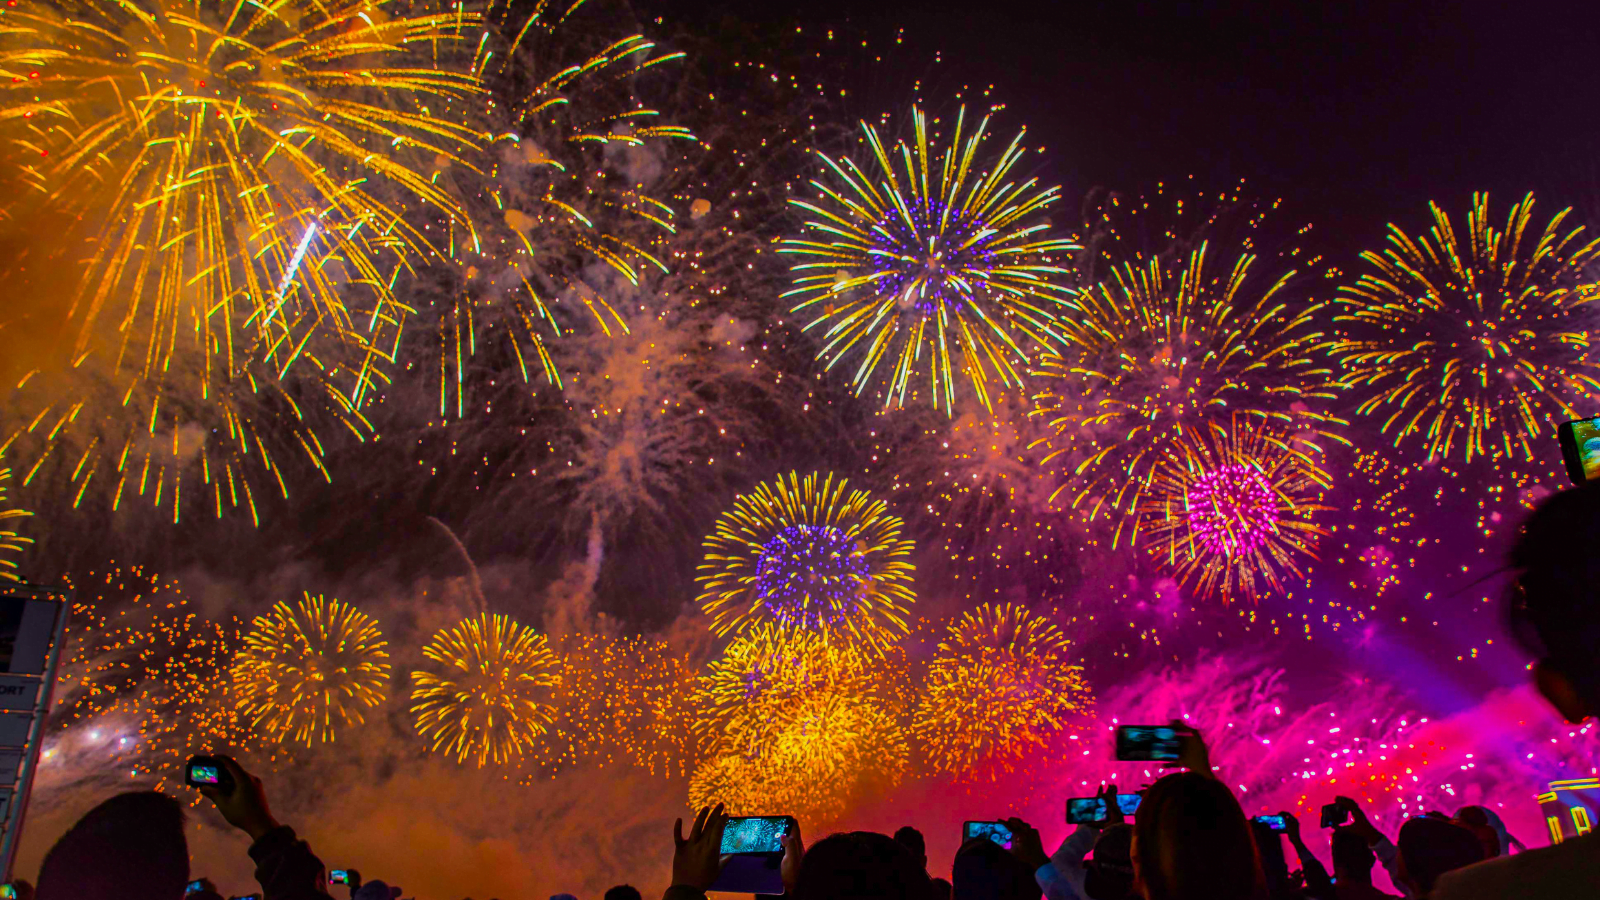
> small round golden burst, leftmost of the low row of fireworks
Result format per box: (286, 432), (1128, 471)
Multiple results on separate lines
(234, 593), (389, 746)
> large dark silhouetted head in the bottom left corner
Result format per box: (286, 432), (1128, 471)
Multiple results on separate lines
(35, 791), (189, 900)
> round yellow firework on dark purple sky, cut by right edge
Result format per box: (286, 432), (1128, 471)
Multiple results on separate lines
(1330, 194), (1600, 463)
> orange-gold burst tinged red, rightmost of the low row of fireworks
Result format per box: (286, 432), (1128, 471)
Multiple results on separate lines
(914, 604), (1091, 777)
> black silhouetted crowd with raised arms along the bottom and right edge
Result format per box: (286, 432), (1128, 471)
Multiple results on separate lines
(13, 484), (1600, 900)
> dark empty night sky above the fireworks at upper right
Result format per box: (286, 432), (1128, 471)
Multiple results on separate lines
(645, 0), (1600, 248)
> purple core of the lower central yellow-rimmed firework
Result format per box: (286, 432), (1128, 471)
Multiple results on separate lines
(755, 525), (870, 629)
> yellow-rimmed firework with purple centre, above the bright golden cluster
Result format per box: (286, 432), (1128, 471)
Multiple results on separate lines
(699, 472), (917, 645)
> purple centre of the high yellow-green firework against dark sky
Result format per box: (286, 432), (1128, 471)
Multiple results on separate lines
(869, 199), (997, 314)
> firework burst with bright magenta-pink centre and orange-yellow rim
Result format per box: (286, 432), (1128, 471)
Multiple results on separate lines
(1136, 416), (1331, 601)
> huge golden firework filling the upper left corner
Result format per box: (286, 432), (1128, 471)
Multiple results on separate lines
(0, 0), (482, 516)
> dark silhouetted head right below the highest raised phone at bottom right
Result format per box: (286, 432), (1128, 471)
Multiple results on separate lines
(1133, 772), (1267, 900)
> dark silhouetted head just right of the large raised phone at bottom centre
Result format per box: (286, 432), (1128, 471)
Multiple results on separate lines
(795, 831), (930, 900)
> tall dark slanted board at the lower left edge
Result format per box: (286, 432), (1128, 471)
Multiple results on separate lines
(0, 581), (72, 881)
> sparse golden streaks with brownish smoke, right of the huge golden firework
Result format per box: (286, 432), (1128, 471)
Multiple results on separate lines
(434, 0), (694, 418)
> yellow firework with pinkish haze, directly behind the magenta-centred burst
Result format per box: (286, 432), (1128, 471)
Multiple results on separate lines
(1035, 186), (1344, 546)
